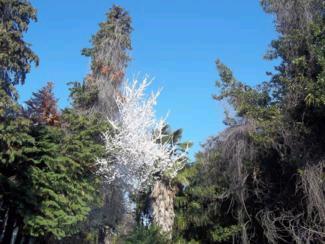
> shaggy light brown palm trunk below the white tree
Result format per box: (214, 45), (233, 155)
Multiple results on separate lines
(150, 181), (176, 237)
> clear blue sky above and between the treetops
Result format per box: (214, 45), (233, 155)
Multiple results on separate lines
(19, 0), (276, 158)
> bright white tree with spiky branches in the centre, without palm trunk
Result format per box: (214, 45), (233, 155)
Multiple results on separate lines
(98, 79), (186, 191)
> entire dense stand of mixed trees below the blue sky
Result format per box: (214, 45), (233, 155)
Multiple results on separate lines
(0, 0), (325, 244)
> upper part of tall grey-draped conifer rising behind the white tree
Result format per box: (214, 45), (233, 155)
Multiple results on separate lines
(72, 5), (132, 118)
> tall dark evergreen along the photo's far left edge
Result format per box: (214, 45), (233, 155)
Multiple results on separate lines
(0, 0), (38, 243)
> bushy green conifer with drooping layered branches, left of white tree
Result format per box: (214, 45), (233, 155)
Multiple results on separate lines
(23, 110), (104, 238)
